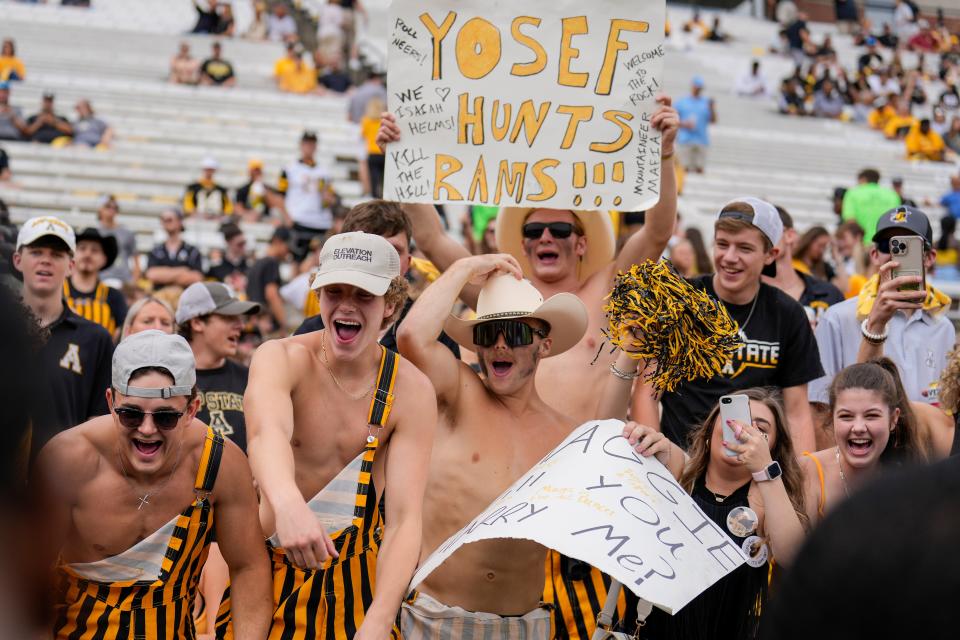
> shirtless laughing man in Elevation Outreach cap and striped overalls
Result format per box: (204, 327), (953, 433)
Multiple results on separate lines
(244, 231), (436, 640)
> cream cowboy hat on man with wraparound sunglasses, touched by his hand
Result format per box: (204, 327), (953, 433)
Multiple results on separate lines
(444, 275), (587, 356)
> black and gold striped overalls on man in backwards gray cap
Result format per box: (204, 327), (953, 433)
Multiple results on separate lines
(54, 428), (223, 640)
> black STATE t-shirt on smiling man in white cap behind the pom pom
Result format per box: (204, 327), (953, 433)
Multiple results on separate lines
(660, 275), (823, 448)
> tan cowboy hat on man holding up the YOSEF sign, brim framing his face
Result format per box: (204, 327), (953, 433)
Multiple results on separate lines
(496, 207), (616, 282)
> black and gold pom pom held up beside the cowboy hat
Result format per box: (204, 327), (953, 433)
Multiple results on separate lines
(603, 260), (741, 391)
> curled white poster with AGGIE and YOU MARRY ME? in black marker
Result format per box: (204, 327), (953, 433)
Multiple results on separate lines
(410, 420), (746, 613)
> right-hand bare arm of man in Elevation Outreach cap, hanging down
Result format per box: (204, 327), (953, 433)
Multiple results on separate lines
(354, 362), (437, 640)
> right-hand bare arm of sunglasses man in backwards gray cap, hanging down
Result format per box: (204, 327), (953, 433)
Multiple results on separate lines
(207, 440), (273, 640)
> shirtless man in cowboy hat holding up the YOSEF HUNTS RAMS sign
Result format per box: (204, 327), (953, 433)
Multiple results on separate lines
(377, 96), (679, 426)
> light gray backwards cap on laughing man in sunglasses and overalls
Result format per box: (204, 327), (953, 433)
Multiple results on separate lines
(113, 329), (197, 398)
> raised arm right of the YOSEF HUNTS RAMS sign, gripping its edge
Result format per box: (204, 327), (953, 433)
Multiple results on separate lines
(615, 95), (680, 271)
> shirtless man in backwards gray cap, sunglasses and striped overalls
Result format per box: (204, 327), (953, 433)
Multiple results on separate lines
(37, 330), (272, 640)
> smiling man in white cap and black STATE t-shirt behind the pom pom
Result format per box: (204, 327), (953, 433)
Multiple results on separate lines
(660, 198), (823, 451)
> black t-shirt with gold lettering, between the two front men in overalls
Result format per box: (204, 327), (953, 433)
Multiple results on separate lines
(197, 359), (249, 451)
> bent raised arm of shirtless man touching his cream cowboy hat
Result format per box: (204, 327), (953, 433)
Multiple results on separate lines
(397, 254), (522, 406)
